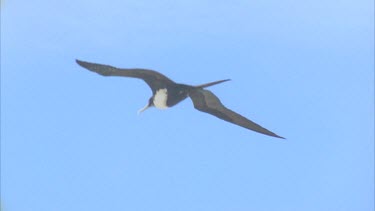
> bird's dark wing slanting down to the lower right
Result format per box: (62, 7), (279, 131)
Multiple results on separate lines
(189, 89), (284, 139)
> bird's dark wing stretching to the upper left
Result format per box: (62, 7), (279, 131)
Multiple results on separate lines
(76, 59), (174, 93)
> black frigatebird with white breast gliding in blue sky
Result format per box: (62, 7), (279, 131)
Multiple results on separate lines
(76, 59), (285, 139)
